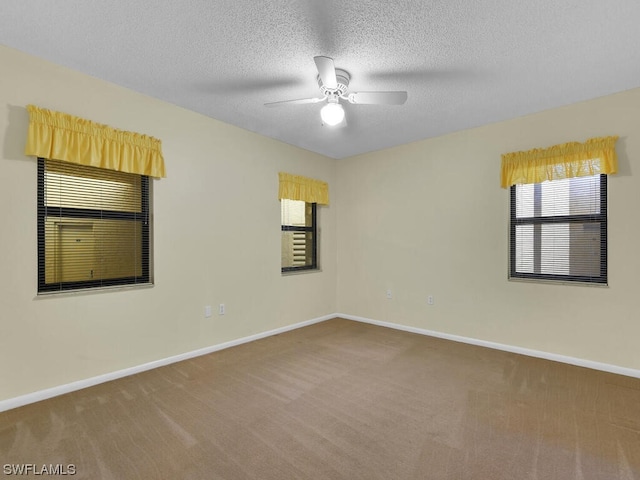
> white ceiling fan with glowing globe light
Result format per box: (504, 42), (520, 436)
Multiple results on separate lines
(264, 56), (407, 126)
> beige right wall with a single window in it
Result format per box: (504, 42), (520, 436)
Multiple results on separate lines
(336, 89), (640, 369)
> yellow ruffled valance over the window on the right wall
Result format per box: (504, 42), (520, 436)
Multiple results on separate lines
(501, 136), (618, 188)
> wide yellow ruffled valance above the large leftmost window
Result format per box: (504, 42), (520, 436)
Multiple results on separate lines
(25, 105), (165, 178)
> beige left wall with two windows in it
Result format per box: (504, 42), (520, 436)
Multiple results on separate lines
(0, 47), (336, 400)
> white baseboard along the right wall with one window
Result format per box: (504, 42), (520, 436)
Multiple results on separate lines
(335, 313), (640, 378)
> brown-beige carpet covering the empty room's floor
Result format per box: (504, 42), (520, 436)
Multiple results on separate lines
(0, 319), (640, 480)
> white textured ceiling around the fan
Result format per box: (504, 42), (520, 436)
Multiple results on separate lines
(0, 0), (640, 158)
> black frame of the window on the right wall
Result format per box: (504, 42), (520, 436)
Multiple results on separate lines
(509, 173), (608, 286)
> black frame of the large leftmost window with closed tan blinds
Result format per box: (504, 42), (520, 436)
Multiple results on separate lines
(37, 157), (152, 294)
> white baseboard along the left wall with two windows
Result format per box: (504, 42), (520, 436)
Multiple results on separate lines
(0, 314), (336, 412)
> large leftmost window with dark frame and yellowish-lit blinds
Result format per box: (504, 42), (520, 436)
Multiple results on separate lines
(38, 158), (150, 292)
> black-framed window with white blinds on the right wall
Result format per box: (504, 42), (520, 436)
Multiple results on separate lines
(509, 175), (607, 284)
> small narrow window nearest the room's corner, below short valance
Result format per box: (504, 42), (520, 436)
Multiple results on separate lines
(280, 199), (318, 272)
